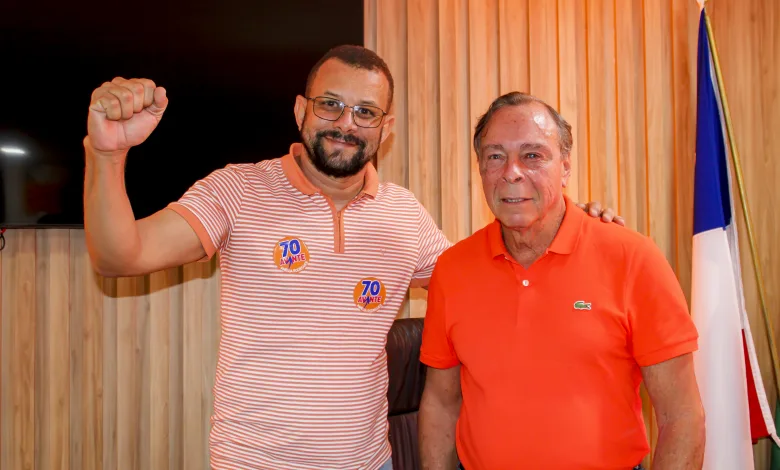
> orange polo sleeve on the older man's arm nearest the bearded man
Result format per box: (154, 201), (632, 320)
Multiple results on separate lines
(420, 262), (460, 369)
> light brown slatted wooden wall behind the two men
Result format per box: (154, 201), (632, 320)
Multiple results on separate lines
(0, 0), (780, 470)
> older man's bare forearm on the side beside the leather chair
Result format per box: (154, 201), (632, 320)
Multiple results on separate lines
(418, 396), (460, 470)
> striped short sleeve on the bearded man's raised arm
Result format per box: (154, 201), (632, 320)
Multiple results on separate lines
(168, 165), (246, 258)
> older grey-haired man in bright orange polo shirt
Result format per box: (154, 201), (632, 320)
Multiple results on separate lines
(419, 93), (704, 470)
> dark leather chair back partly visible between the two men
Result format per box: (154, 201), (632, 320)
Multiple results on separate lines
(385, 318), (425, 470)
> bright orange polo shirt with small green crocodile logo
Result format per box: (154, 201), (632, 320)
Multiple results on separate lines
(421, 198), (698, 470)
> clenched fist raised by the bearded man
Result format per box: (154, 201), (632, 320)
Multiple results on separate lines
(87, 77), (168, 154)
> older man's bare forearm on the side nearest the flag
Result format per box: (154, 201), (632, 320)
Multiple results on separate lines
(653, 416), (705, 470)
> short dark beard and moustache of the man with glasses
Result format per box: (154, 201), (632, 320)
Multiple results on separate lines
(301, 129), (376, 178)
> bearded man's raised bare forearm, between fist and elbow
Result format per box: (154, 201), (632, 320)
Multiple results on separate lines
(84, 138), (141, 275)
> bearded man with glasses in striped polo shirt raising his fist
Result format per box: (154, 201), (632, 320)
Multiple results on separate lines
(84, 46), (612, 470)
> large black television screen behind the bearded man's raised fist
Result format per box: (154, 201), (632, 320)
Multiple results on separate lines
(0, 0), (363, 227)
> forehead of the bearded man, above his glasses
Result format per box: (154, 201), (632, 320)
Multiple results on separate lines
(310, 59), (390, 111)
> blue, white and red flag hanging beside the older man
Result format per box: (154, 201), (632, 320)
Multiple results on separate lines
(691, 9), (780, 470)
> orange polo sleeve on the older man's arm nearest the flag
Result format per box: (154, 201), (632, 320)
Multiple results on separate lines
(626, 239), (699, 367)
